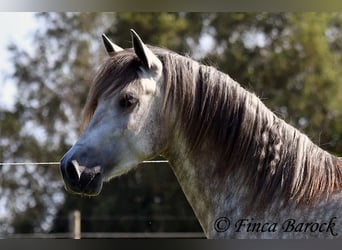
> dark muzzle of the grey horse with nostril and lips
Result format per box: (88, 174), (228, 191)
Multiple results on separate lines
(60, 158), (103, 196)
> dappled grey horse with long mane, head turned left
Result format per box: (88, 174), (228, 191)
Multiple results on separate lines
(60, 30), (342, 238)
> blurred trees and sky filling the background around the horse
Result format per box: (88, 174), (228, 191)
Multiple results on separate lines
(0, 12), (342, 238)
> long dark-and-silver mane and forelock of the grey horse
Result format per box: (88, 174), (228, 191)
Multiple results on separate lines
(83, 46), (342, 209)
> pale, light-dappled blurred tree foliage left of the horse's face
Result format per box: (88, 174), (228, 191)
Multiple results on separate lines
(0, 13), (108, 234)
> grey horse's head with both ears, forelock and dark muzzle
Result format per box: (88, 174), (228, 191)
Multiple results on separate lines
(60, 30), (168, 195)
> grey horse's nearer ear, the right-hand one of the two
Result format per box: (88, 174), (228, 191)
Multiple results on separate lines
(130, 29), (162, 70)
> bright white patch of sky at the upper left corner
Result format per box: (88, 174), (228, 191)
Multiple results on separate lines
(0, 12), (38, 109)
